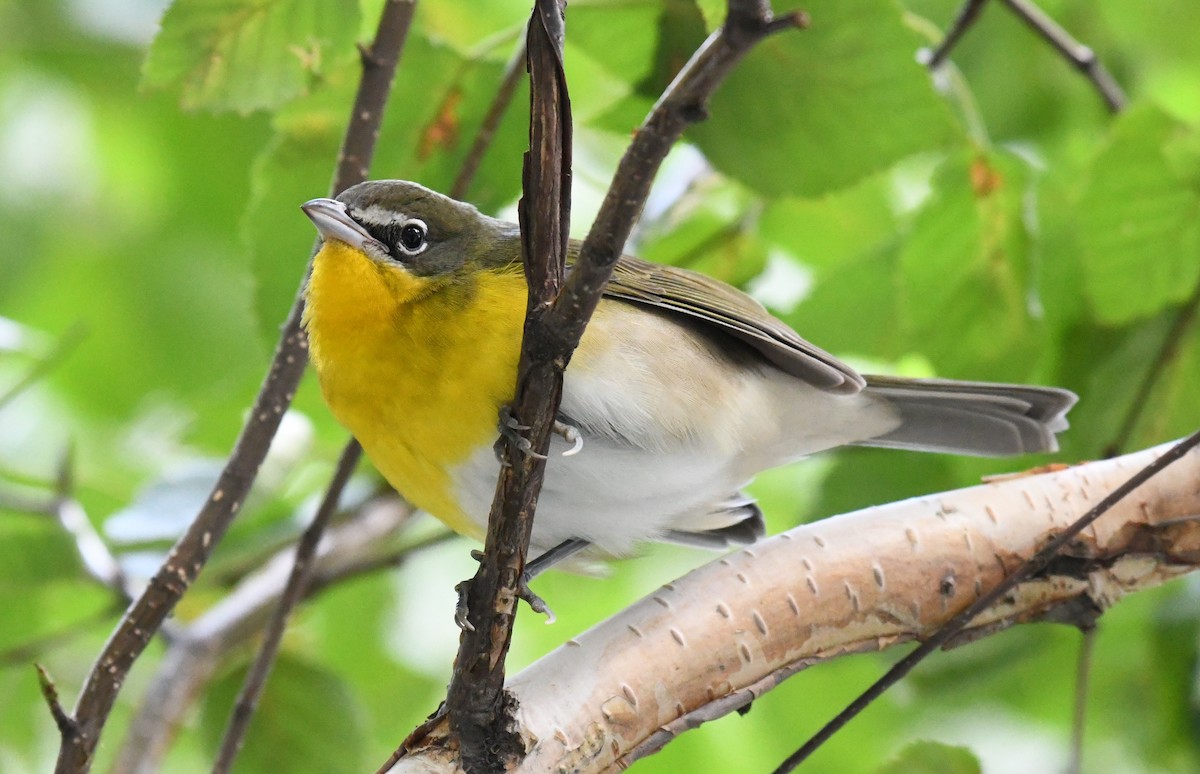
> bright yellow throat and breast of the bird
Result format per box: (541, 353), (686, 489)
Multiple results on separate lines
(305, 241), (527, 538)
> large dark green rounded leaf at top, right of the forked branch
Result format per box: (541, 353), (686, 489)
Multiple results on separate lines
(688, 0), (958, 196)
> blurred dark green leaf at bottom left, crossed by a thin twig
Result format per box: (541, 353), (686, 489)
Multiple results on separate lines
(200, 653), (367, 774)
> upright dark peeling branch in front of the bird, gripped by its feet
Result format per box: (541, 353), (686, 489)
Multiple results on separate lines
(446, 0), (571, 772)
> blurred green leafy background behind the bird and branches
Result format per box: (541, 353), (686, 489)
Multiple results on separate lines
(0, 0), (1200, 772)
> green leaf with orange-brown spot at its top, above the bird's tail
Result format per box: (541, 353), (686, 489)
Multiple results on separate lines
(899, 154), (1039, 380)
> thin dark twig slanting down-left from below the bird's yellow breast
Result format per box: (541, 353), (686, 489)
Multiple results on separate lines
(212, 440), (362, 774)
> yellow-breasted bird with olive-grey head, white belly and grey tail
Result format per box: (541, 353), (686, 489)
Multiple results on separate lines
(301, 180), (1076, 562)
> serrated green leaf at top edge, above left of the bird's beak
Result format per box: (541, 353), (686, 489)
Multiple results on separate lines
(142, 0), (359, 113)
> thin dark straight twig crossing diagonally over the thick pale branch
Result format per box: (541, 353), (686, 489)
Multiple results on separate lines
(775, 431), (1200, 774)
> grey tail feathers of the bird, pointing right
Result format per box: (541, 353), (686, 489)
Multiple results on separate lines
(856, 376), (1076, 457)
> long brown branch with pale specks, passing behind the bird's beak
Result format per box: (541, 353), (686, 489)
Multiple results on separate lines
(55, 0), (415, 774)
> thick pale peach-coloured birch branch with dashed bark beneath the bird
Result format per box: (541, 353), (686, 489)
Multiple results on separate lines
(395, 436), (1200, 772)
